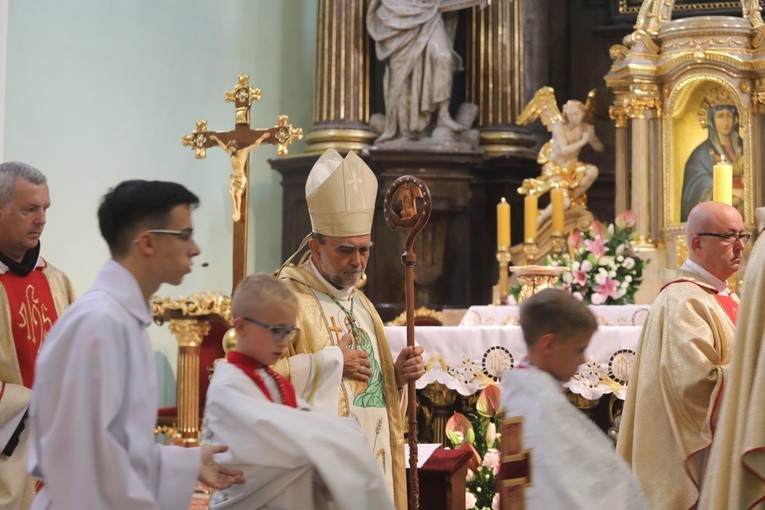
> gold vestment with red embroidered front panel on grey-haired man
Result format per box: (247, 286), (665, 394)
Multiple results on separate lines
(0, 258), (74, 509)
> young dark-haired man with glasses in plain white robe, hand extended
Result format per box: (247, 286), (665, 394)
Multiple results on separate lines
(29, 180), (242, 510)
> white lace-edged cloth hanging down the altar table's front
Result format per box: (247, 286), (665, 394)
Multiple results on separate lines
(385, 326), (641, 400)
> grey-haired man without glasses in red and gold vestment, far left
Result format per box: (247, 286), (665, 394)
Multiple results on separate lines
(0, 161), (74, 510)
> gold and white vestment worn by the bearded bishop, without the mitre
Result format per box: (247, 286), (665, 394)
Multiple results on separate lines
(274, 260), (407, 510)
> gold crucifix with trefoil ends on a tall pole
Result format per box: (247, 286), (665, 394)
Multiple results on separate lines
(182, 74), (303, 288)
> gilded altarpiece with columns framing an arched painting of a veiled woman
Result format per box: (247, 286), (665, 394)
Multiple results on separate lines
(605, 0), (765, 293)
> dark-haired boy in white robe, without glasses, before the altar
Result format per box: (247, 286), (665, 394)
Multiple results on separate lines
(499, 289), (648, 510)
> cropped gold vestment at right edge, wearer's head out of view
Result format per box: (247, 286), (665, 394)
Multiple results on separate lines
(699, 235), (765, 510)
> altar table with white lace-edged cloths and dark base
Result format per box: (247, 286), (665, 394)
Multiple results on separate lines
(385, 305), (649, 443)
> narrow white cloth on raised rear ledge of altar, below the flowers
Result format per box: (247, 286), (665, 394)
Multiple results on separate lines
(459, 305), (651, 326)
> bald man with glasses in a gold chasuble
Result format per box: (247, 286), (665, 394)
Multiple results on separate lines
(616, 202), (749, 509)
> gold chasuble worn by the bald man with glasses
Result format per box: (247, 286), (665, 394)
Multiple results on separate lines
(616, 266), (735, 510)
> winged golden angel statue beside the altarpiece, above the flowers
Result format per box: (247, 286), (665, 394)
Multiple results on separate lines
(516, 87), (605, 225)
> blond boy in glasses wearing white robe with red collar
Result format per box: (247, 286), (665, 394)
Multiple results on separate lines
(204, 273), (393, 510)
